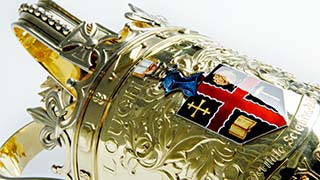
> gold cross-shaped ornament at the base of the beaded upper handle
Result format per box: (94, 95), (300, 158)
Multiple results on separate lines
(60, 22), (118, 71)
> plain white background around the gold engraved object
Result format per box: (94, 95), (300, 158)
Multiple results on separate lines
(0, 0), (320, 176)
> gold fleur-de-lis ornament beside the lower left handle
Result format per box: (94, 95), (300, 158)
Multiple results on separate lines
(28, 77), (76, 180)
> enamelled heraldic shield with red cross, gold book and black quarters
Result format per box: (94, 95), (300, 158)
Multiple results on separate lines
(177, 65), (287, 144)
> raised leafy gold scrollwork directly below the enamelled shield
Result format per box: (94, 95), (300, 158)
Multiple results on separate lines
(107, 79), (238, 180)
